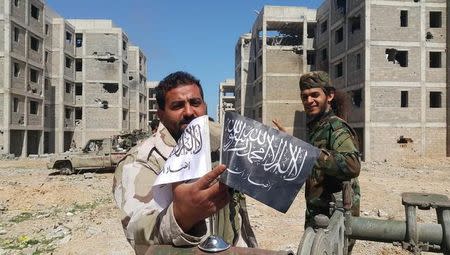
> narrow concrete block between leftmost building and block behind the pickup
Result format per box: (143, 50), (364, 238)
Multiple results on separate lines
(44, 7), (76, 153)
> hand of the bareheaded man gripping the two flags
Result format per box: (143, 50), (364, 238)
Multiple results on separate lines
(172, 165), (230, 232)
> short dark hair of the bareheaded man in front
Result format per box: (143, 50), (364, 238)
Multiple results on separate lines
(156, 71), (203, 110)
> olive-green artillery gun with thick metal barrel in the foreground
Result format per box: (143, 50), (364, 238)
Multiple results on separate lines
(146, 182), (450, 255)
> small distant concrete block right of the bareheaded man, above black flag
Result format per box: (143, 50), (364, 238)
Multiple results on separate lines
(217, 79), (236, 123)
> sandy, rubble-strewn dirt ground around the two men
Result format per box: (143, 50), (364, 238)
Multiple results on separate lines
(0, 158), (450, 255)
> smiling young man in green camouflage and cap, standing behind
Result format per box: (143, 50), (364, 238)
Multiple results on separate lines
(299, 71), (361, 228)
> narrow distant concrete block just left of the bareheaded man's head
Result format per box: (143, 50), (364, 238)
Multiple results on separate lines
(128, 46), (148, 130)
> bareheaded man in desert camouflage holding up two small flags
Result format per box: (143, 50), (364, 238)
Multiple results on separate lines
(113, 72), (256, 254)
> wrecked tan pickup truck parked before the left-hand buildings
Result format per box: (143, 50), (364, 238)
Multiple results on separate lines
(47, 138), (129, 174)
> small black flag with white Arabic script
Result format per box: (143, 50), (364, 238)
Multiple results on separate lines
(221, 112), (320, 213)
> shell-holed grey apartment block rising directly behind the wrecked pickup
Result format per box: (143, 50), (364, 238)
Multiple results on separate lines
(68, 19), (135, 149)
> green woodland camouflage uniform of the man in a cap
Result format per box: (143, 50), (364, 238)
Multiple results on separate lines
(305, 110), (361, 225)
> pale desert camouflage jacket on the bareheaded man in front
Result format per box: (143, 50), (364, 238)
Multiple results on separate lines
(113, 123), (256, 254)
